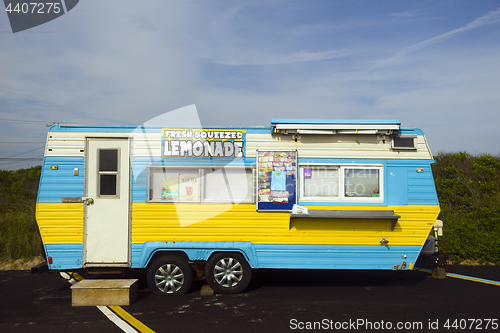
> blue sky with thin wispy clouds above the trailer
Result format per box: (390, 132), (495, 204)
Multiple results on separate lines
(0, 0), (500, 169)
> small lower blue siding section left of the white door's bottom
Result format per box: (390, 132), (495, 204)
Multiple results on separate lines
(45, 244), (83, 270)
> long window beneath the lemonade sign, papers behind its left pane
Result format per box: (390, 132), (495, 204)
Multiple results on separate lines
(148, 166), (255, 203)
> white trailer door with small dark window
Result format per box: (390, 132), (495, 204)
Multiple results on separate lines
(84, 138), (130, 266)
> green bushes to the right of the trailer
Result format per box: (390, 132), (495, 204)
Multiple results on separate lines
(432, 152), (500, 264)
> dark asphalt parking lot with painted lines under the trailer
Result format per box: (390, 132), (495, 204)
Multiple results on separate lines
(0, 266), (500, 333)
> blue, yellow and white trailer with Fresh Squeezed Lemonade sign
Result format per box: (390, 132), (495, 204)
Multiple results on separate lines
(36, 119), (440, 294)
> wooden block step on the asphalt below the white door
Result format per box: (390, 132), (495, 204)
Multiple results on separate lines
(71, 279), (138, 306)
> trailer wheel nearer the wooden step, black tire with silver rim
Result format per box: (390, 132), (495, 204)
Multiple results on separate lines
(147, 256), (193, 295)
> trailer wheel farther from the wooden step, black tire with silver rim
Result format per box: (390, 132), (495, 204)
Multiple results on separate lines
(205, 252), (252, 294)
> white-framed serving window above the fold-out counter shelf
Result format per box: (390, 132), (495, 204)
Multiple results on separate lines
(299, 165), (384, 202)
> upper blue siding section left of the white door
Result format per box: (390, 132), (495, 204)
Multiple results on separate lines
(37, 157), (85, 202)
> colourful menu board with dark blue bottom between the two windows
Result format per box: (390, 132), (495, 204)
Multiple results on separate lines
(257, 150), (297, 210)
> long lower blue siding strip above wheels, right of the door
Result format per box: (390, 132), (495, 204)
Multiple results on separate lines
(132, 241), (422, 269)
